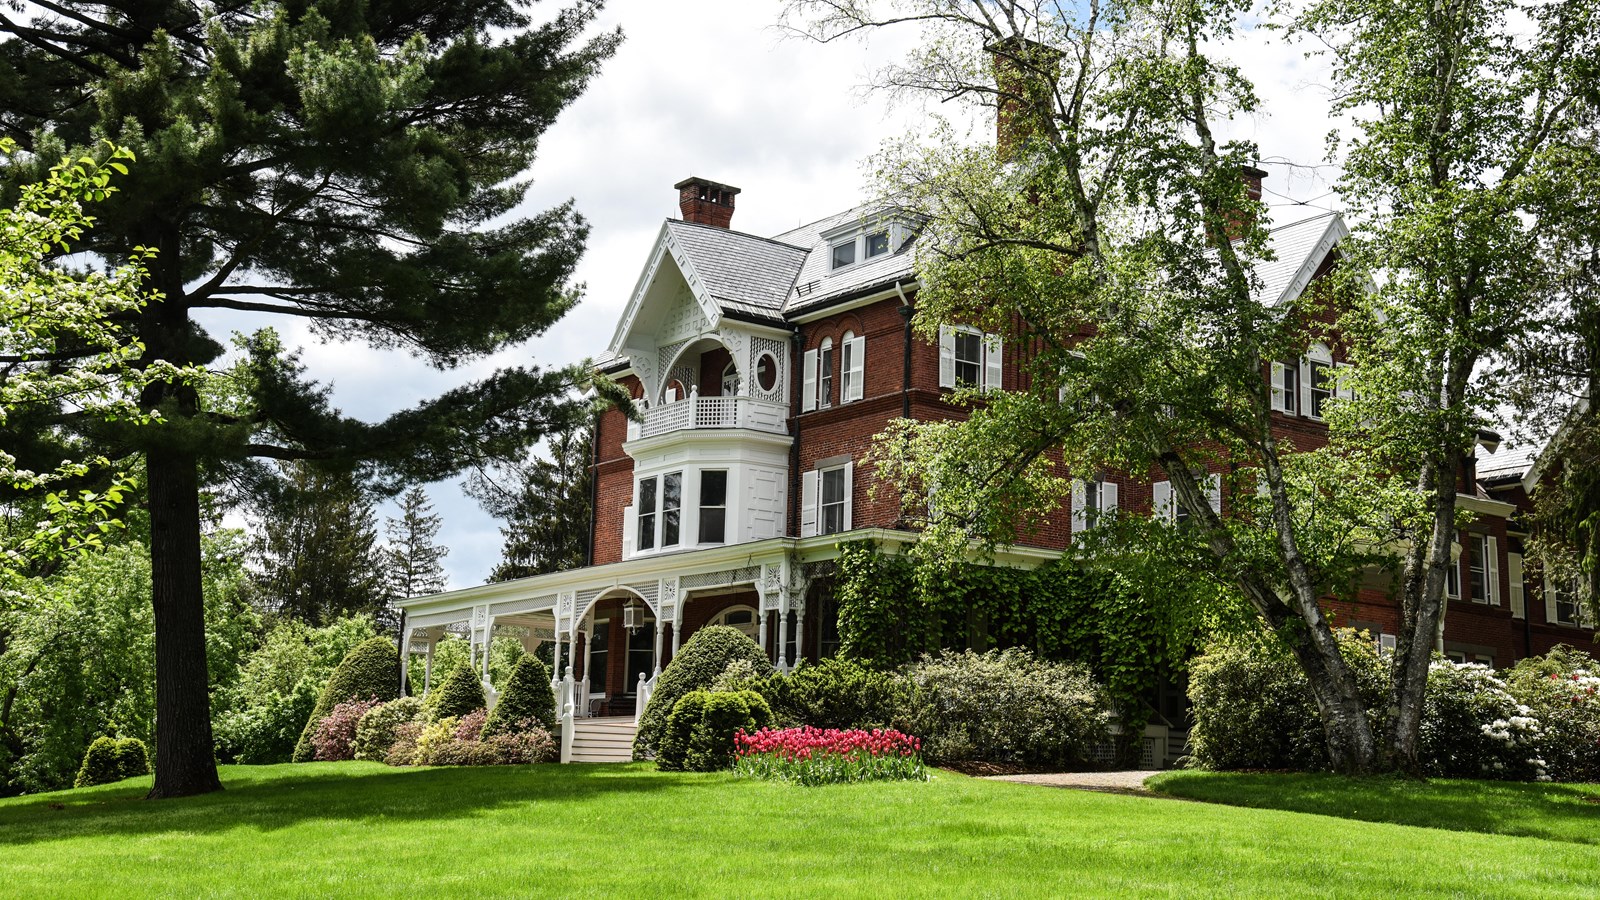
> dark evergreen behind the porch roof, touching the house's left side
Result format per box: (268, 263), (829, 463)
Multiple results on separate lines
(466, 426), (594, 581)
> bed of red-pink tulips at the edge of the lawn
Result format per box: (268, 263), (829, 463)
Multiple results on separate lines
(733, 725), (928, 785)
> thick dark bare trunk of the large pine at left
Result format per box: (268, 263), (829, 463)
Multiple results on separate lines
(146, 447), (222, 799)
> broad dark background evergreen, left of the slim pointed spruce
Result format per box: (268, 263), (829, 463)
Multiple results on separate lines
(254, 463), (392, 628)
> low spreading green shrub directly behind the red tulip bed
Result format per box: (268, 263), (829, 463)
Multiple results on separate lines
(729, 657), (912, 730)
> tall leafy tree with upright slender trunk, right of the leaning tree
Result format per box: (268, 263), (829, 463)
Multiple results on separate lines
(1294, 0), (1600, 770)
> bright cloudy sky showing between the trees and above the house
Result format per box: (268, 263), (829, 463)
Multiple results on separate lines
(200, 0), (1333, 588)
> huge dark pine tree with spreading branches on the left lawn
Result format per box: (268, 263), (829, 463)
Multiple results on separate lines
(0, 0), (621, 798)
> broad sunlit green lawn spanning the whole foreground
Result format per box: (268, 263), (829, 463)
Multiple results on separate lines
(0, 762), (1600, 900)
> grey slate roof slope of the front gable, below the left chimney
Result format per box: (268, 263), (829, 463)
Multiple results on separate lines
(667, 219), (810, 322)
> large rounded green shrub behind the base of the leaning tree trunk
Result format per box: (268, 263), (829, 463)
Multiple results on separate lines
(1189, 631), (1387, 770)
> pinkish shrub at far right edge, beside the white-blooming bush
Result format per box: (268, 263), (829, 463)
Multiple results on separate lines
(1506, 645), (1600, 781)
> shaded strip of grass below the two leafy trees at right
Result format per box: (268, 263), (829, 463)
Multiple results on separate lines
(1149, 772), (1600, 846)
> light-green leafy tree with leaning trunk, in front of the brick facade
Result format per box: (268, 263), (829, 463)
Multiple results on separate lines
(787, 0), (1381, 772)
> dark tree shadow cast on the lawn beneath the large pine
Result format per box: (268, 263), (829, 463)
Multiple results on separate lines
(0, 762), (699, 846)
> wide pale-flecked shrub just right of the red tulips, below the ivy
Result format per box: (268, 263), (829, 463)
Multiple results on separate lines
(907, 649), (1110, 767)
